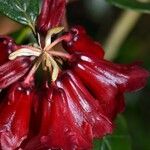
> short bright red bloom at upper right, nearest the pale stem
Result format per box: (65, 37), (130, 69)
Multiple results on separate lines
(63, 26), (104, 58)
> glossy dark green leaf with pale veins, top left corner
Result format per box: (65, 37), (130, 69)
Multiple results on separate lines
(0, 0), (41, 29)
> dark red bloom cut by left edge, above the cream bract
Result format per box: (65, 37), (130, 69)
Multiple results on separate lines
(0, 36), (16, 65)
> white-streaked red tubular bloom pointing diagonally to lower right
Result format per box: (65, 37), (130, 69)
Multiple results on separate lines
(57, 72), (112, 137)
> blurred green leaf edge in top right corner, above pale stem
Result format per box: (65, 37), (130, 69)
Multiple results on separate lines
(107, 0), (150, 13)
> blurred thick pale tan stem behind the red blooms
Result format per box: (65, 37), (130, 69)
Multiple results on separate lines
(104, 10), (142, 60)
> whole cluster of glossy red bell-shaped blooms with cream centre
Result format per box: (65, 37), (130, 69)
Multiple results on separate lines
(0, 0), (149, 150)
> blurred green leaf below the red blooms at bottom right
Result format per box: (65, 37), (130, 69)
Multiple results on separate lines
(94, 115), (132, 150)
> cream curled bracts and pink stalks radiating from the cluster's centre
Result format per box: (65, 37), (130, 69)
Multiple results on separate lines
(9, 27), (71, 85)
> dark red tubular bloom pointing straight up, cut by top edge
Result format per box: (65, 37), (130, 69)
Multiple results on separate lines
(36, 0), (66, 33)
